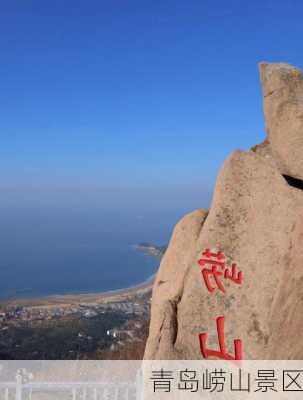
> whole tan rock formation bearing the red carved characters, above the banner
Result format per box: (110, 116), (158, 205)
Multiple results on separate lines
(145, 63), (303, 359)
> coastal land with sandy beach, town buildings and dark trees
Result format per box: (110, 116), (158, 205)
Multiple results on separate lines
(0, 245), (162, 359)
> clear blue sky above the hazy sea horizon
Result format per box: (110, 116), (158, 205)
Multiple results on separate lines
(0, 0), (303, 209)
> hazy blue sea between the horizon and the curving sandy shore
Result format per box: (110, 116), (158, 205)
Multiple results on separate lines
(0, 190), (197, 299)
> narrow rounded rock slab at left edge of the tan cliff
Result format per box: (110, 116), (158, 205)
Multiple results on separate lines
(145, 210), (207, 360)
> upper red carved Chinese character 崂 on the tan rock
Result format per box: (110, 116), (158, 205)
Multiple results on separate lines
(198, 249), (243, 293)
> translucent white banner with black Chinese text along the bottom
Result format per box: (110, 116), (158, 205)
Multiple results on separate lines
(0, 360), (303, 400)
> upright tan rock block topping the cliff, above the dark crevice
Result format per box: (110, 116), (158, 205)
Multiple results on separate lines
(260, 63), (303, 179)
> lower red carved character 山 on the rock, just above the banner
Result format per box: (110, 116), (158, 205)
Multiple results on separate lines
(199, 317), (243, 361)
